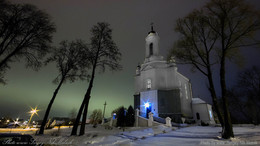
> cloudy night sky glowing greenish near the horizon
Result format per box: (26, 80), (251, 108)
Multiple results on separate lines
(0, 0), (260, 119)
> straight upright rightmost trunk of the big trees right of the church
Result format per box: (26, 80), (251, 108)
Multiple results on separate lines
(220, 50), (234, 139)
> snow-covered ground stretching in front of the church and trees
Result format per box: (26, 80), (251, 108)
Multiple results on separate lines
(2, 125), (260, 146)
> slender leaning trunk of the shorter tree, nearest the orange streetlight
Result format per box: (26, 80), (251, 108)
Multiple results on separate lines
(39, 77), (65, 134)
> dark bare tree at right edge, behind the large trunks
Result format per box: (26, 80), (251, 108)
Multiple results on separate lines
(229, 66), (260, 124)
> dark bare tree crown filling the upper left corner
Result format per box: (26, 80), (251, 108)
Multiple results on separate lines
(0, 0), (55, 81)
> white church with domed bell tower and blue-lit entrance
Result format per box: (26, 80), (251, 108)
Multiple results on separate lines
(134, 26), (215, 124)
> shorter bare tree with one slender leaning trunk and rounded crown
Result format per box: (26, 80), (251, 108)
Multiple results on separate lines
(39, 40), (90, 134)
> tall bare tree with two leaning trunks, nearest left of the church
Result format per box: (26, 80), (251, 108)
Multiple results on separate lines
(71, 22), (121, 135)
